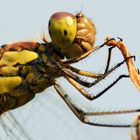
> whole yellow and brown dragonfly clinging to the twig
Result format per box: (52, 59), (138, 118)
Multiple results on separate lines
(0, 12), (139, 139)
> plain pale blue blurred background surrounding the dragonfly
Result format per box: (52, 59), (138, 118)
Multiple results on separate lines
(0, 0), (140, 140)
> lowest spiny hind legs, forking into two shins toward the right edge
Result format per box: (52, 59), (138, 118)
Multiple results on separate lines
(54, 82), (140, 127)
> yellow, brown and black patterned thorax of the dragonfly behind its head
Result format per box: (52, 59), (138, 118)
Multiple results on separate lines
(0, 42), (61, 114)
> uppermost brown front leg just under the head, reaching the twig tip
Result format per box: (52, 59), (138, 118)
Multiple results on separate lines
(60, 38), (114, 65)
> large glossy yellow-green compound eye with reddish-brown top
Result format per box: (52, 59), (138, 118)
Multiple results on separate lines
(48, 12), (77, 49)
